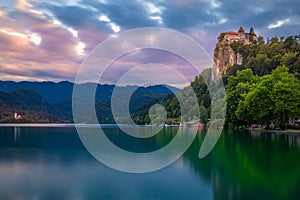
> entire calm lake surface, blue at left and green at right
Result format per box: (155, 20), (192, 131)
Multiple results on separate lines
(0, 127), (300, 200)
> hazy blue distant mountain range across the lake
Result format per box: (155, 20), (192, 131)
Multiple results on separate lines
(0, 81), (180, 123)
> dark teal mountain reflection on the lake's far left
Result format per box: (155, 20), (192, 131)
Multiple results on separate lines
(0, 127), (92, 166)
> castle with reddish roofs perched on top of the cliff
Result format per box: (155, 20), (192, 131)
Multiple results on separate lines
(223, 27), (257, 44)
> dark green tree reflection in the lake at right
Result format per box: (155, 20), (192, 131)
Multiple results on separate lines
(184, 131), (300, 199)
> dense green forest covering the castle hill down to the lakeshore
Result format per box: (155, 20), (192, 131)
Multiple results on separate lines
(134, 34), (300, 128)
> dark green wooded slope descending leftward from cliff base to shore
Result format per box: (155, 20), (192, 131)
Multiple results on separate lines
(133, 69), (212, 124)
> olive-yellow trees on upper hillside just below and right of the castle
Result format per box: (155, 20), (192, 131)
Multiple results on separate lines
(225, 36), (300, 77)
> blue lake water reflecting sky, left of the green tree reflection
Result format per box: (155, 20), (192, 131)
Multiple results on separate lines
(0, 127), (213, 200)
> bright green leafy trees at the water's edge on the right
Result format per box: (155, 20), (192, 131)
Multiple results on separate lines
(227, 66), (300, 128)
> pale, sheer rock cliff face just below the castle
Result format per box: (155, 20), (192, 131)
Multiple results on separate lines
(214, 42), (243, 74)
